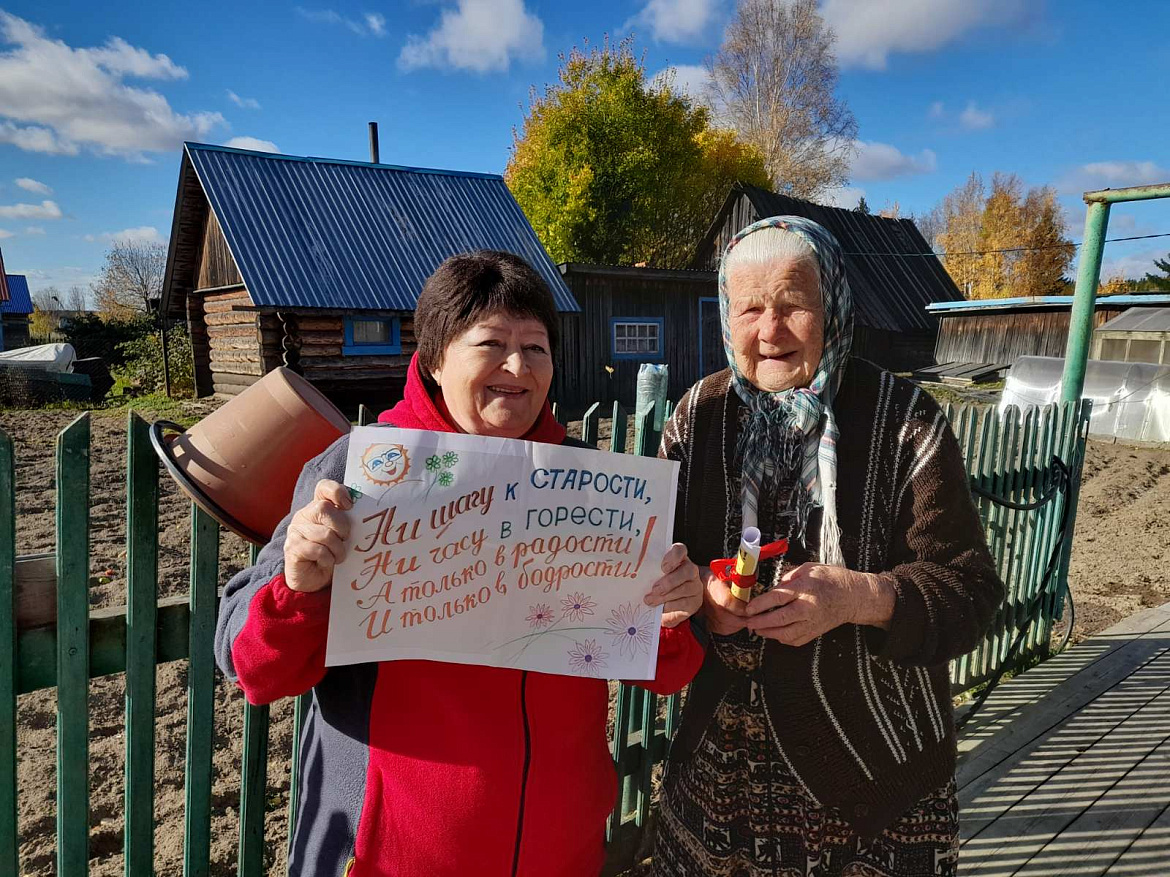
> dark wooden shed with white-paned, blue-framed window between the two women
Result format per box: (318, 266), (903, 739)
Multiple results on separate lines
(550, 262), (727, 416)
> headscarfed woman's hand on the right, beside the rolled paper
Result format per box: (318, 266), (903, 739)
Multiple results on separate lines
(746, 564), (894, 645)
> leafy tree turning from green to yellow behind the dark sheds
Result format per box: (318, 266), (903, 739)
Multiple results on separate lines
(504, 39), (771, 268)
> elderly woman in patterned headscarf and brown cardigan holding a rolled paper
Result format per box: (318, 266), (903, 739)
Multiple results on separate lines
(654, 216), (1003, 877)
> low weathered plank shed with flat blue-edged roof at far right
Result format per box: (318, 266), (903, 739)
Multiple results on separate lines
(927, 295), (1170, 366)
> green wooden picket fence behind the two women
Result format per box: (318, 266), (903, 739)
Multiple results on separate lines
(0, 403), (1088, 877)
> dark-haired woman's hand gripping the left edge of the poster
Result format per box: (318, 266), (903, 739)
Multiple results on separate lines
(284, 478), (353, 593)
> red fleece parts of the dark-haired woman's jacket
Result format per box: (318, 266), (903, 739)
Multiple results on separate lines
(232, 361), (703, 877)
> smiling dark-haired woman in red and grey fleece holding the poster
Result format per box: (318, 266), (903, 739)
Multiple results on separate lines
(216, 251), (703, 877)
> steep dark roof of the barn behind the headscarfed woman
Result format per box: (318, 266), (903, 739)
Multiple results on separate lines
(695, 182), (963, 332)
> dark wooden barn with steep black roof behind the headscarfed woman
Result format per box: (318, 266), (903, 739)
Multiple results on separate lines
(690, 182), (963, 371)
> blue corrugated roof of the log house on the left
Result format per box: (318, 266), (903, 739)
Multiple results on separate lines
(186, 143), (580, 311)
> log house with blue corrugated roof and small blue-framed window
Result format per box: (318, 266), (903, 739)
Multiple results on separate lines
(161, 143), (578, 409)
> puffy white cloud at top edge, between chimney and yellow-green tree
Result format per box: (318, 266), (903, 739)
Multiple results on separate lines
(398, 0), (544, 74)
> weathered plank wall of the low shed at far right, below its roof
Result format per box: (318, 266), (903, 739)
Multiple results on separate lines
(935, 308), (1121, 364)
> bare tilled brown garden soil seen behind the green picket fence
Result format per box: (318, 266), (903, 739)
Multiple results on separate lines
(0, 403), (1170, 876)
